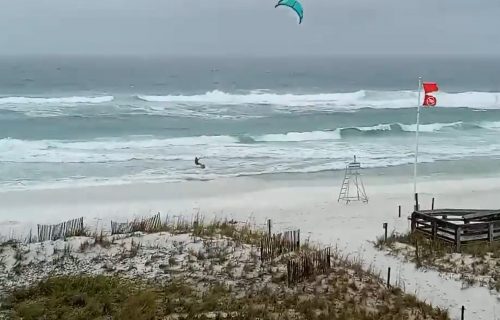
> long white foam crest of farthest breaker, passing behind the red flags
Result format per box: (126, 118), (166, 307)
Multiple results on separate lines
(137, 90), (500, 110)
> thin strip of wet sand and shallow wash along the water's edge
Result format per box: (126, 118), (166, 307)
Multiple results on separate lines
(0, 156), (500, 195)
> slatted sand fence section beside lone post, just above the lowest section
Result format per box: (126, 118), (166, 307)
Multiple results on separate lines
(260, 230), (300, 261)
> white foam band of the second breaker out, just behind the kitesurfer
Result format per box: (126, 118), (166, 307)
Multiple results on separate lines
(0, 122), (500, 163)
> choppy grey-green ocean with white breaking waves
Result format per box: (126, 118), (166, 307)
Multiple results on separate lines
(0, 56), (500, 190)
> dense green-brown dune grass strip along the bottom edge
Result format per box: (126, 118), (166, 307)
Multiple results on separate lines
(3, 276), (449, 320)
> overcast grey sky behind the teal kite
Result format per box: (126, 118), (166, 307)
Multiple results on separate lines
(0, 0), (500, 55)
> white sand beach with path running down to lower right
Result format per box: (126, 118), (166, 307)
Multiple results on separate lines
(0, 175), (500, 320)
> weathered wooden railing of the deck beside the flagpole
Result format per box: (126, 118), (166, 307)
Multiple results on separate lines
(411, 209), (500, 251)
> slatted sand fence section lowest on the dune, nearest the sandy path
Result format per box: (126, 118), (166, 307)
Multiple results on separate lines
(287, 248), (332, 286)
